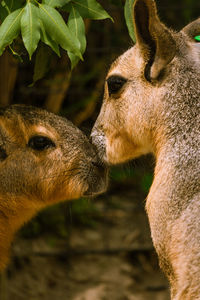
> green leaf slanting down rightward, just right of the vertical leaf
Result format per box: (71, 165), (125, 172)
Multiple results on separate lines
(39, 4), (82, 59)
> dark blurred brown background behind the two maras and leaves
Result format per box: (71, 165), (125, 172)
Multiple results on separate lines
(0, 0), (200, 300)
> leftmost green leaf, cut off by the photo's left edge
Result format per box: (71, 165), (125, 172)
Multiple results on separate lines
(0, 8), (24, 55)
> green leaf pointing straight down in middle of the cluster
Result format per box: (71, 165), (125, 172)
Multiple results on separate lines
(21, 1), (40, 59)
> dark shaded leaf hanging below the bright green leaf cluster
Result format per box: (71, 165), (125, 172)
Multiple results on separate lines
(31, 45), (52, 86)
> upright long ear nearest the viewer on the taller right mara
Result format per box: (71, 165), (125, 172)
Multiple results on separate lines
(133, 0), (176, 81)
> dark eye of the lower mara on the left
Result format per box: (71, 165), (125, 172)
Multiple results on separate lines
(28, 135), (56, 151)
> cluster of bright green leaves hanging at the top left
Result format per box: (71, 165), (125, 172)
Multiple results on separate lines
(0, 0), (112, 67)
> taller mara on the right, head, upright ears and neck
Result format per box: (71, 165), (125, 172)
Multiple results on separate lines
(91, 0), (200, 300)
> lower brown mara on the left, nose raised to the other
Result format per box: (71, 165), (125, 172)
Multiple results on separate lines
(0, 105), (106, 271)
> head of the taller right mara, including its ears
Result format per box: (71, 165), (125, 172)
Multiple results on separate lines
(91, 0), (200, 164)
